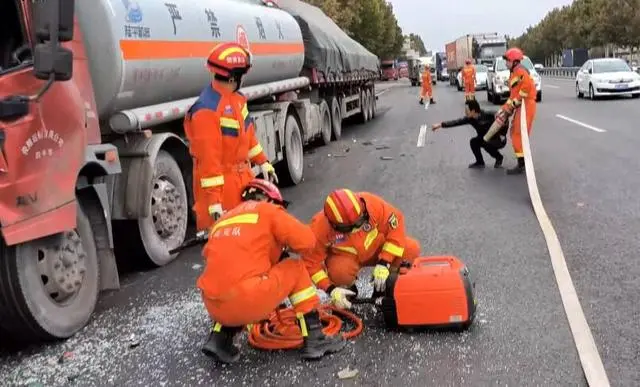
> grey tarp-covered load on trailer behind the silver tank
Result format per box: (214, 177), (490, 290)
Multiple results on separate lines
(277, 0), (380, 75)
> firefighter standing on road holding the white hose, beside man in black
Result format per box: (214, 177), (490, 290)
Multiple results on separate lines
(484, 47), (537, 175)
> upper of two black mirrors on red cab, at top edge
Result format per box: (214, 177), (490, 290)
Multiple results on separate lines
(32, 0), (75, 42)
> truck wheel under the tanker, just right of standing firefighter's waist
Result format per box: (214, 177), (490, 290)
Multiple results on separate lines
(276, 114), (304, 185)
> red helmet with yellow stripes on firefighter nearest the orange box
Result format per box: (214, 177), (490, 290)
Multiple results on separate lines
(324, 188), (367, 232)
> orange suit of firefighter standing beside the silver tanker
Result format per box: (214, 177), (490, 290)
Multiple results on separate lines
(184, 81), (268, 230)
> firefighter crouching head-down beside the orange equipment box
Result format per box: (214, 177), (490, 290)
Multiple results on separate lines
(302, 189), (420, 309)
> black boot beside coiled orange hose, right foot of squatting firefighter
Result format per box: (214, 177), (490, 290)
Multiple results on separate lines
(298, 310), (347, 360)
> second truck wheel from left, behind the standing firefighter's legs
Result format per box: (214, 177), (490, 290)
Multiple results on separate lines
(138, 150), (189, 266)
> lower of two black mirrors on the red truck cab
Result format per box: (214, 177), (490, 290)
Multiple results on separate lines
(33, 42), (73, 81)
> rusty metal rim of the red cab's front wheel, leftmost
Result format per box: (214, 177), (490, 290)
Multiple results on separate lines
(32, 231), (87, 306)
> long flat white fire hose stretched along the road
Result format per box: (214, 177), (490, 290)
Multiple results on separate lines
(520, 105), (610, 387)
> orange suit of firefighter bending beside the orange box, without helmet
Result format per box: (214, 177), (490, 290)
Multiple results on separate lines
(303, 192), (420, 290)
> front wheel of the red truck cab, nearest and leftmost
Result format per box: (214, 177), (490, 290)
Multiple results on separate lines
(0, 203), (100, 342)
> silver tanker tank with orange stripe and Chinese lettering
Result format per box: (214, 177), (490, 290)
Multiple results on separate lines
(75, 0), (304, 120)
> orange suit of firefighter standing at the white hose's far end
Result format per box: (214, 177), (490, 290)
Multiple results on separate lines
(502, 65), (537, 157)
